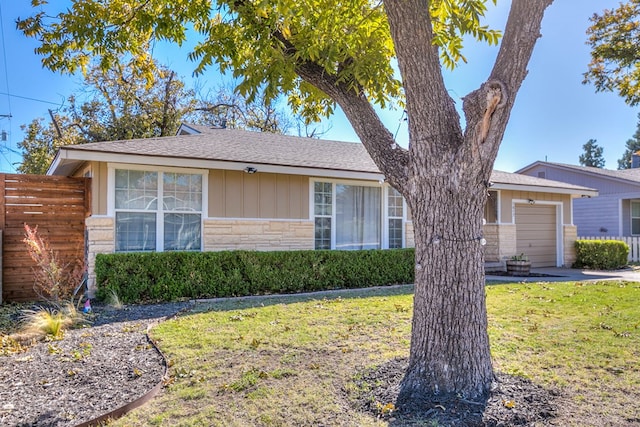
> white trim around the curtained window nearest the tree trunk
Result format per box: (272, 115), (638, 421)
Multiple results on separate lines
(309, 177), (407, 250)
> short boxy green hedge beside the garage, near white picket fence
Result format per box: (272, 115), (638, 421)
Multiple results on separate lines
(573, 240), (629, 270)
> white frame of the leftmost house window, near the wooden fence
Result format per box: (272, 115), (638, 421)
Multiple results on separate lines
(107, 163), (209, 253)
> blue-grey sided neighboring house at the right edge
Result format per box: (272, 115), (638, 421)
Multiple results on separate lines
(516, 161), (640, 237)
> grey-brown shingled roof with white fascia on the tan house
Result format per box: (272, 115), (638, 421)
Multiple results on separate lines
(49, 125), (595, 195)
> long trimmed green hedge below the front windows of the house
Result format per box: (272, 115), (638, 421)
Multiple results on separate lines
(95, 249), (414, 303)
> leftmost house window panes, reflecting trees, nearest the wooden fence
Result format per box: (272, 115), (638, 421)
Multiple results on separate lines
(114, 169), (203, 252)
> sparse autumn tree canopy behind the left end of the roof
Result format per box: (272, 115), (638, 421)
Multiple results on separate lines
(17, 61), (195, 174)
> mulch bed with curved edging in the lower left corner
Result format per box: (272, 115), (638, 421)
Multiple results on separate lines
(0, 303), (188, 427)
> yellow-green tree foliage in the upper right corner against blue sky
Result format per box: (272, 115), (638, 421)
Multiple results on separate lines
(583, 0), (640, 105)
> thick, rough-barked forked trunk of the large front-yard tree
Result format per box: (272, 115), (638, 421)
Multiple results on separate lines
(297, 0), (552, 405)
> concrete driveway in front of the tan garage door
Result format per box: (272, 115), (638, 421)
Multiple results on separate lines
(486, 267), (640, 282)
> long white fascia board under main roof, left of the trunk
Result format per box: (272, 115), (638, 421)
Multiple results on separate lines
(51, 150), (384, 181)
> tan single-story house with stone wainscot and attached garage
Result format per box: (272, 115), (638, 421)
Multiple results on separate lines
(49, 125), (597, 292)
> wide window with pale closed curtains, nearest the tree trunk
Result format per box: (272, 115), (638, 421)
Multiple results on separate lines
(313, 182), (403, 250)
